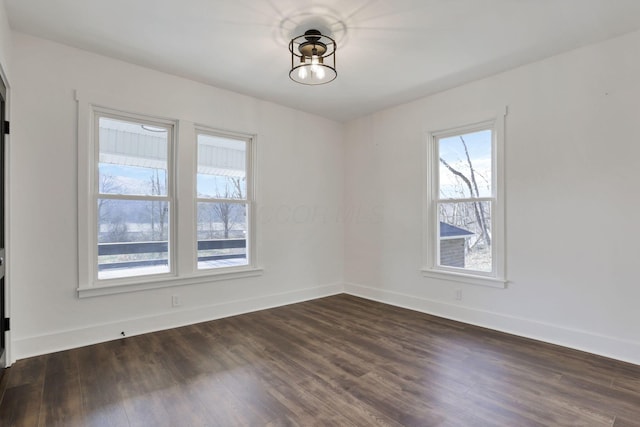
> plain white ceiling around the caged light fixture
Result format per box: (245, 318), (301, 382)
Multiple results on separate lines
(5, 0), (640, 121)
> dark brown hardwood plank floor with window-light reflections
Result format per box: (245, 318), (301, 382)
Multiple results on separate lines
(0, 295), (640, 427)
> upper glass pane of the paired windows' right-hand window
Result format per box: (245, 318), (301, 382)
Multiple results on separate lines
(197, 134), (247, 199)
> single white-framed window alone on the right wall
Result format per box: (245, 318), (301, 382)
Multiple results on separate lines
(423, 113), (504, 287)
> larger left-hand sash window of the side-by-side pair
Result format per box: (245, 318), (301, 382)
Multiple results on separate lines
(95, 111), (173, 280)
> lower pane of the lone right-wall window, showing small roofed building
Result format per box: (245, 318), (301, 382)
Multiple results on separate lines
(438, 202), (493, 273)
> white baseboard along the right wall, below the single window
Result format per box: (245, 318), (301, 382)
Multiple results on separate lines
(344, 283), (640, 365)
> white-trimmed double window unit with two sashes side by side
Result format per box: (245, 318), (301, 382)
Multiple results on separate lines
(78, 97), (261, 297)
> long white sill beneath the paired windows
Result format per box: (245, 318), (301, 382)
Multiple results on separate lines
(77, 268), (263, 298)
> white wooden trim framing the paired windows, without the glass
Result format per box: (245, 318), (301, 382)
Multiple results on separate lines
(76, 91), (263, 298)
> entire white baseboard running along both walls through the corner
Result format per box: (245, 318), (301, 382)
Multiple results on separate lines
(11, 283), (640, 365)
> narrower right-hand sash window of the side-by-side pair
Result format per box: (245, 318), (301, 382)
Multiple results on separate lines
(196, 129), (252, 270)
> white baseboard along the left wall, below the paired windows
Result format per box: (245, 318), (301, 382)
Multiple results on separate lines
(11, 284), (344, 363)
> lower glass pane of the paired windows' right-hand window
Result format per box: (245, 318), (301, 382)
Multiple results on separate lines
(198, 202), (248, 269)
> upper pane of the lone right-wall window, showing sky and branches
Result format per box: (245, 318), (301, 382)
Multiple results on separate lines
(438, 130), (492, 199)
